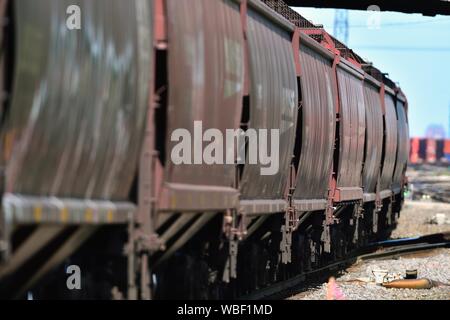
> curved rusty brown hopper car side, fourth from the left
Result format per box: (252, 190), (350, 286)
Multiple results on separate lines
(294, 45), (336, 199)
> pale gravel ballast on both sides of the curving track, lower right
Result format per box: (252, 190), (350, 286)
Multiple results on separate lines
(289, 201), (450, 300)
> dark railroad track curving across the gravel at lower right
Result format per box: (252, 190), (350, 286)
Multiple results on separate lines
(242, 233), (450, 300)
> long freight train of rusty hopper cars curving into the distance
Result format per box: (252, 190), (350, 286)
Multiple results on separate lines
(0, 0), (409, 299)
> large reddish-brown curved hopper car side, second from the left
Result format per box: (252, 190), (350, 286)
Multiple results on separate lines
(165, 0), (244, 187)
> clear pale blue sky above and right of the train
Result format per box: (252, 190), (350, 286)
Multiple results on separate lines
(294, 8), (450, 138)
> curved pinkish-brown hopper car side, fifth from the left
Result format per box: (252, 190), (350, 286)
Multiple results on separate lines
(337, 67), (366, 188)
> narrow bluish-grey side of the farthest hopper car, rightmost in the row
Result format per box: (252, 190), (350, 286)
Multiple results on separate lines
(393, 100), (409, 189)
